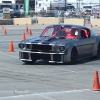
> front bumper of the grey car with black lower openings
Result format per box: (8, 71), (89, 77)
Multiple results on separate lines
(19, 51), (67, 62)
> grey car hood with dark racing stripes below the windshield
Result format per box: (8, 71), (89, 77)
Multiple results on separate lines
(23, 37), (76, 45)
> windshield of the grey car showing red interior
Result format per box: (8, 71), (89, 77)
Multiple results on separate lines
(40, 27), (78, 38)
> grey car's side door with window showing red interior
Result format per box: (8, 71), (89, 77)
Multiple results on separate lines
(77, 28), (96, 58)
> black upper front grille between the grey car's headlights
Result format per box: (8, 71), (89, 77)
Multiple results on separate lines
(32, 44), (52, 52)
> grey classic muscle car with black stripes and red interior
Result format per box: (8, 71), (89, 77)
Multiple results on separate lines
(18, 24), (100, 63)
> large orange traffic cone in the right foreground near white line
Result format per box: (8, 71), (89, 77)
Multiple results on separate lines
(92, 71), (100, 91)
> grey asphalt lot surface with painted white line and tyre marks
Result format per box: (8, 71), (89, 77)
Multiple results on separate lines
(0, 25), (100, 100)
